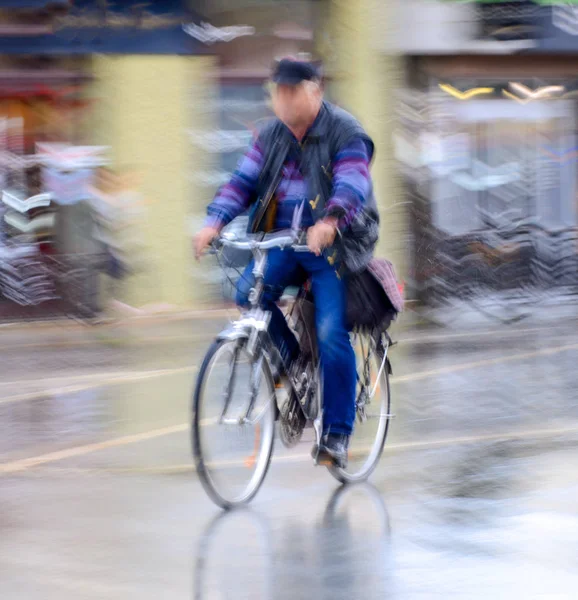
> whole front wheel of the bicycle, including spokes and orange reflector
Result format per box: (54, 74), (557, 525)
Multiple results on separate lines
(191, 340), (275, 508)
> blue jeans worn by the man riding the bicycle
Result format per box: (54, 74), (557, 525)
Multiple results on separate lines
(237, 249), (357, 435)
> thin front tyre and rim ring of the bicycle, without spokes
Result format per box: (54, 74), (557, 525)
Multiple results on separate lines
(191, 340), (276, 510)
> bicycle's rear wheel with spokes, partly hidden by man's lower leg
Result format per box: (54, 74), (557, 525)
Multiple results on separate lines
(329, 333), (391, 483)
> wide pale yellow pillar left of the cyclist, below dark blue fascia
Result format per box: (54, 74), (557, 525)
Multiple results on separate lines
(91, 56), (212, 308)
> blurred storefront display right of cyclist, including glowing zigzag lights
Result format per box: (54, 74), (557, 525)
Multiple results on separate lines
(396, 71), (578, 306)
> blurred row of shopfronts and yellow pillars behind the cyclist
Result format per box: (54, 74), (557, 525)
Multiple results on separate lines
(0, 0), (578, 316)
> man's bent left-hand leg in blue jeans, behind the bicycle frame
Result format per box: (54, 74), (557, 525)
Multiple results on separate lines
(237, 249), (300, 365)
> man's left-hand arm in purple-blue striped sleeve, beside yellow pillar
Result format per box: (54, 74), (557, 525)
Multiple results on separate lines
(205, 140), (264, 230)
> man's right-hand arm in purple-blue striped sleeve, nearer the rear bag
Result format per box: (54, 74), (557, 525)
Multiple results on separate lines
(326, 138), (371, 229)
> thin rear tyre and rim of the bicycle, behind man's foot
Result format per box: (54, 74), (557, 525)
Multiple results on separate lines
(328, 338), (391, 483)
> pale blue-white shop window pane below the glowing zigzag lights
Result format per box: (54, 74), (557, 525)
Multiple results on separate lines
(432, 100), (577, 235)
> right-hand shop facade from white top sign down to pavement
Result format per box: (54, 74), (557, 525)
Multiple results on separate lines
(392, 0), (578, 305)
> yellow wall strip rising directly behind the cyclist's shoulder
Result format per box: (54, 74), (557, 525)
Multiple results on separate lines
(322, 0), (408, 279)
